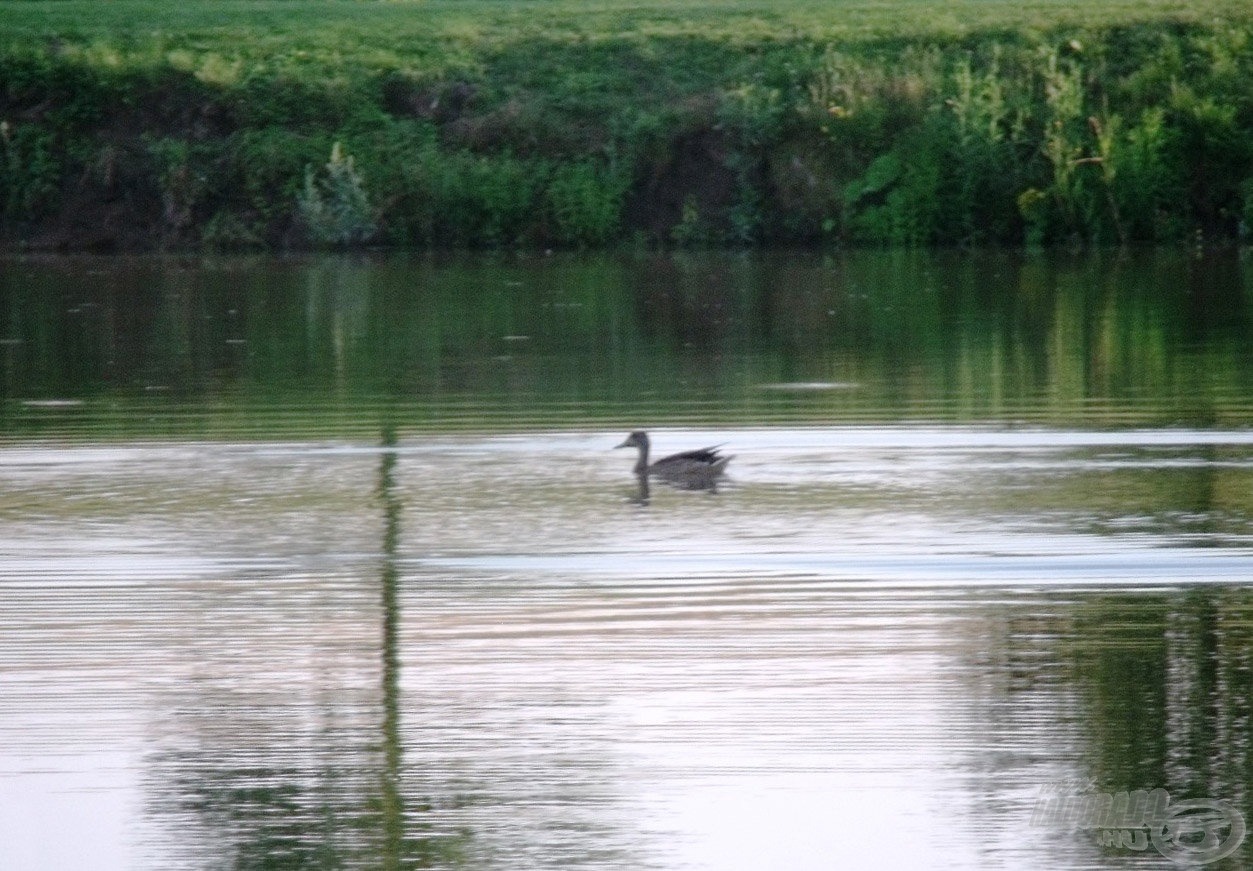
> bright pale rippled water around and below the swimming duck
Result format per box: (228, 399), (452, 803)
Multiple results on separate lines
(0, 427), (1253, 868)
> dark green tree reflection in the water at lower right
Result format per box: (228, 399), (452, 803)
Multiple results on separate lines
(1022, 587), (1253, 868)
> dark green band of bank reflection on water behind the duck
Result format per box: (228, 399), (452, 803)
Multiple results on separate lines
(0, 251), (1253, 437)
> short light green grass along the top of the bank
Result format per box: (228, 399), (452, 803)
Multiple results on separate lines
(0, 0), (1253, 91)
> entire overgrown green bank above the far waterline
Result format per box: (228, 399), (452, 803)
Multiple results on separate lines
(0, 0), (1253, 249)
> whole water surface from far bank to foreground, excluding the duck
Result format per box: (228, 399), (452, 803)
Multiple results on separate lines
(0, 251), (1253, 871)
